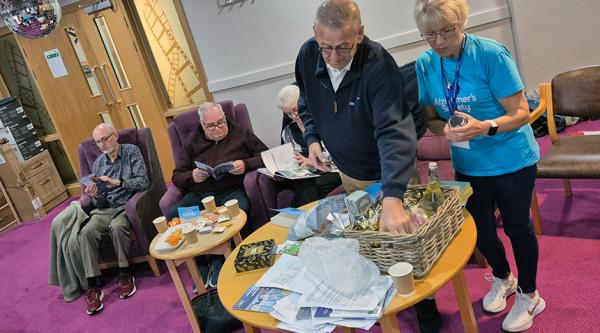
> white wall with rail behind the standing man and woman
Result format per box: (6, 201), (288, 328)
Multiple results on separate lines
(182, 0), (514, 146)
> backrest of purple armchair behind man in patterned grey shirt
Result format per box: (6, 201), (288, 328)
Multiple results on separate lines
(78, 128), (156, 193)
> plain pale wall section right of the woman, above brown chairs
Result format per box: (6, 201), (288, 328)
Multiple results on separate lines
(509, 0), (600, 90)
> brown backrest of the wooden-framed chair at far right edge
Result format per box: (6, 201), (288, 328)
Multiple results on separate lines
(552, 65), (600, 118)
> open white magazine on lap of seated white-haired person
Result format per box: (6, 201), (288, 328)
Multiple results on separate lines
(257, 143), (319, 179)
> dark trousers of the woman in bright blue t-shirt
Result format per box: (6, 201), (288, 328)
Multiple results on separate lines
(456, 164), (538, 293)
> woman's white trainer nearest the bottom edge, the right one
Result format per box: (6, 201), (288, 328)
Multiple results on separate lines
(502, 288), (546, 332)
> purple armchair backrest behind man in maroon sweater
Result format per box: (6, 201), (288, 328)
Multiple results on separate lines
(168, 100), (252, 161)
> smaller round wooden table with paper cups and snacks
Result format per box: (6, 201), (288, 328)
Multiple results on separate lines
(150, 210), (247, 333)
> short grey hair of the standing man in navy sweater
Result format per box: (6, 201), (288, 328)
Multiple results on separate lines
(314, 0), (362, 32)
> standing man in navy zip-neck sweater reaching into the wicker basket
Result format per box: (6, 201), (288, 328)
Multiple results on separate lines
(296, 0), (441, 333)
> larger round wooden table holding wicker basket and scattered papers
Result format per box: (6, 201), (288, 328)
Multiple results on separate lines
(217, 210), (477, 333)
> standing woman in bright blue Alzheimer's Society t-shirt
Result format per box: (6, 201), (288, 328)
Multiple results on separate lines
(415, 0), (545, 332)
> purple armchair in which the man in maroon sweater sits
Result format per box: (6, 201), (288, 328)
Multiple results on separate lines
(160, 100), (261, 231)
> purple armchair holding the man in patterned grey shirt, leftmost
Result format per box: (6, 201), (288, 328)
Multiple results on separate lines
(78, 128), (166, 276)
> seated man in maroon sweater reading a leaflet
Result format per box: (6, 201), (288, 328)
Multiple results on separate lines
(167, 103), (268, 219)
